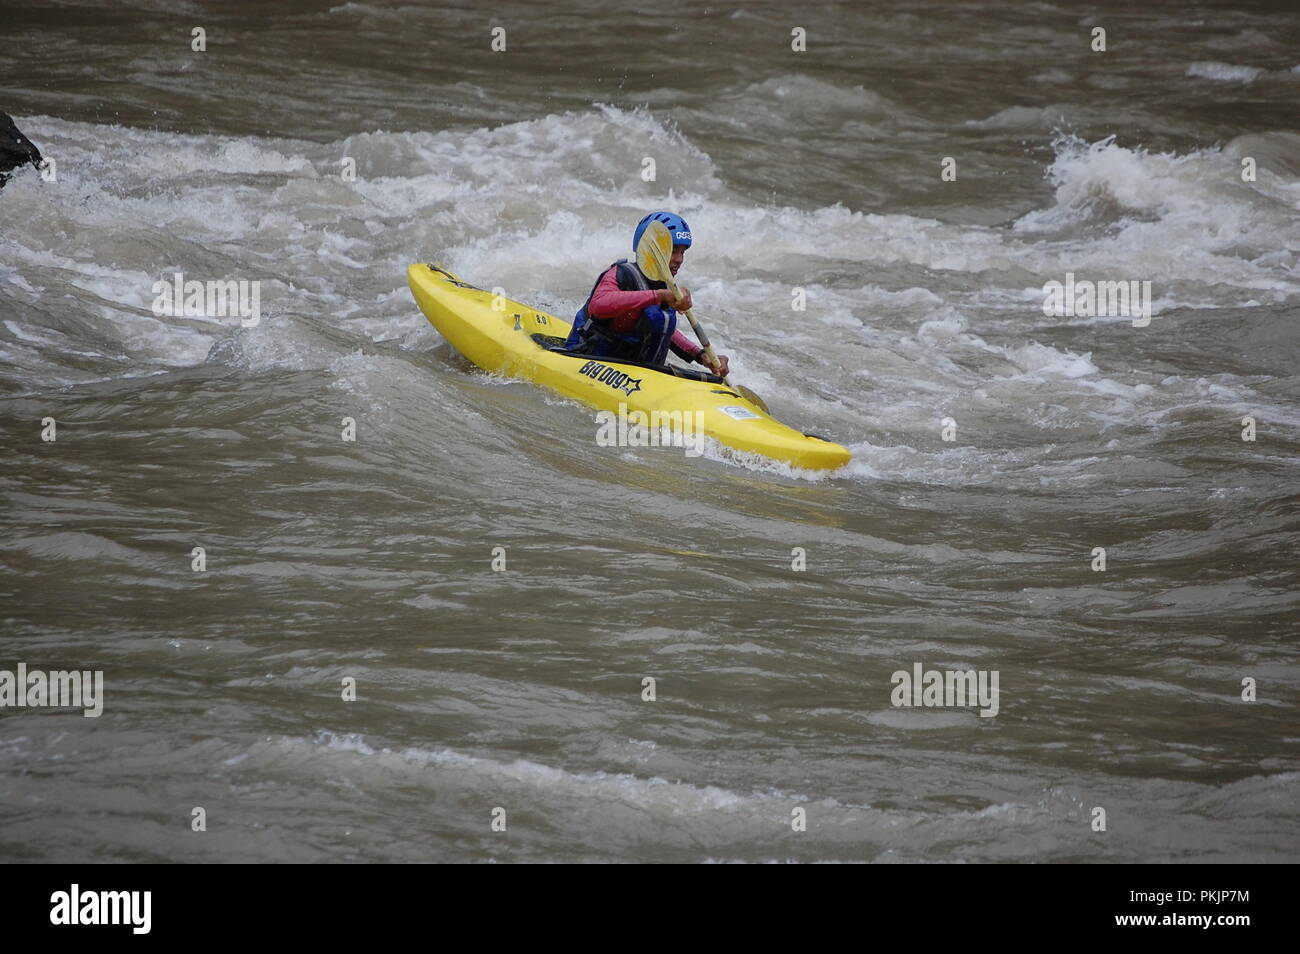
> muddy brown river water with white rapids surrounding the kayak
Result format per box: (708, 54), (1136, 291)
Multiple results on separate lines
(0, 0), (1300, 862)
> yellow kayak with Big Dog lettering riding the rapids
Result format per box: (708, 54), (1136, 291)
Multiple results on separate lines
(407, 264), (853, 471)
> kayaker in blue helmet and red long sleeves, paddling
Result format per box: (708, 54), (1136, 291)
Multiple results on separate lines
(564, 212), (728, 376)
